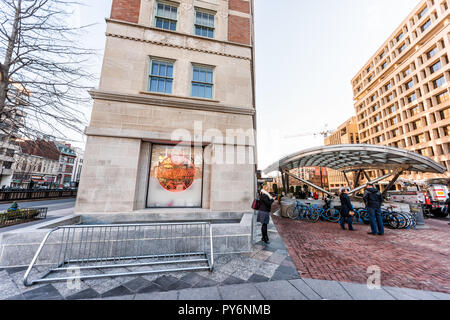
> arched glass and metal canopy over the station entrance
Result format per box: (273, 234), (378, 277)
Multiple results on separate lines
(264, 144), (446, 196)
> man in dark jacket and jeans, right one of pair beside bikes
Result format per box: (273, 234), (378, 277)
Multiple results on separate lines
(364, 184), (384, 236)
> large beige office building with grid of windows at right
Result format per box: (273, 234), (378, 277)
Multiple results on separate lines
(352, 0), (450, 179)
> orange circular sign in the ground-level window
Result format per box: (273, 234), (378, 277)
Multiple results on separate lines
(155, 155), (196, 192)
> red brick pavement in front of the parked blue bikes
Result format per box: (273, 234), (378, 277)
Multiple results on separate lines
(272, 211), (450, 293)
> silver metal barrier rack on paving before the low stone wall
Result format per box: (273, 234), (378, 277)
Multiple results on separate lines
(24, 222), (214, 286)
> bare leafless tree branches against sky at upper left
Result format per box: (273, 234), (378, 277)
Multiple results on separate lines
(0, 0), (95, 140)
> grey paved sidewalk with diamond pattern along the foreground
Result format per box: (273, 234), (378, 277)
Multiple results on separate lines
(0, 212), (450, 300)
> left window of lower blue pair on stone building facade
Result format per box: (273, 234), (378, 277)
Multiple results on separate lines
(149, 60), (173, 94)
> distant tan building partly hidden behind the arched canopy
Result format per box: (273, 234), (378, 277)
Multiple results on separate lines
(325, 117), (359, 192)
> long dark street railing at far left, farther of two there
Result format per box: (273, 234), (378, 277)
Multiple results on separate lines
(0, 189), (77, 202)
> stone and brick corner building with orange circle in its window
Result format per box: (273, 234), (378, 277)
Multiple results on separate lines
(75, 0), (256, 219)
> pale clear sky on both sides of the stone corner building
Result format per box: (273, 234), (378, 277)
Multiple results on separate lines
(73, 0), (419, 169)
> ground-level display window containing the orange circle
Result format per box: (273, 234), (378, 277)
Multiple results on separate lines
(147, 145), (203, 208)
